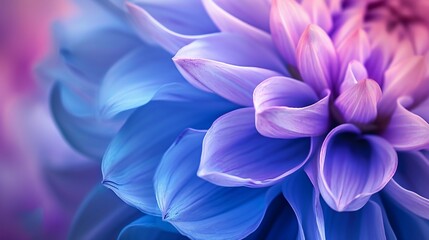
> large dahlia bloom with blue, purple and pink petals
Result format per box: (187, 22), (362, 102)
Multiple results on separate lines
(46, 0), (429, 239)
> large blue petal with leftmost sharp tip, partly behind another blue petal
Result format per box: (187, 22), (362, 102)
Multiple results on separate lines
(102, 99), (232, 215)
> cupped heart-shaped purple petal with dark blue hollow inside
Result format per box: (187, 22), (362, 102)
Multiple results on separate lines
(318, 124), (397, 211)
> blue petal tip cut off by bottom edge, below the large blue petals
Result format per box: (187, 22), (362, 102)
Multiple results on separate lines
(118, 215), (187, 240)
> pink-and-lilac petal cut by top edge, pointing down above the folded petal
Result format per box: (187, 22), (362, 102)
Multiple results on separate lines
(270, 0), (311, 66)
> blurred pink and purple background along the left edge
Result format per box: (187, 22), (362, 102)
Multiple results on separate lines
(0, 0), (101, 240)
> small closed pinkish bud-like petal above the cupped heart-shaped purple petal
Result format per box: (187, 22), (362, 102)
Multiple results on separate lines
(335, 79), (382, 125)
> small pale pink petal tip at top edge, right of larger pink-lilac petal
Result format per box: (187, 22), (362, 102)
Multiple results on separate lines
(301, 0), (333, 32)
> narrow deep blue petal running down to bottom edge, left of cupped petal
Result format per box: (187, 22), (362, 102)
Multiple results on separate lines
(283, 171), (325, 239)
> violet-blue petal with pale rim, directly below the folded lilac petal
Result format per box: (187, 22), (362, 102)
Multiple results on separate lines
(198, 108), (312, 187)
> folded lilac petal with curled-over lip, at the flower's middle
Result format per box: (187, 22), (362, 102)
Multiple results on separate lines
(253, 77), (330, 138)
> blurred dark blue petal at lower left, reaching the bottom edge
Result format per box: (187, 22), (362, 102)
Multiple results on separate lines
(68, 185), (141, 240)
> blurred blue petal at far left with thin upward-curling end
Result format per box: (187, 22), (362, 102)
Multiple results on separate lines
(50, 84), (122, 159)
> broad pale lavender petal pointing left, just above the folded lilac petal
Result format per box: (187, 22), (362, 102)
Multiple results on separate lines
(174, 34), (284, 106)
